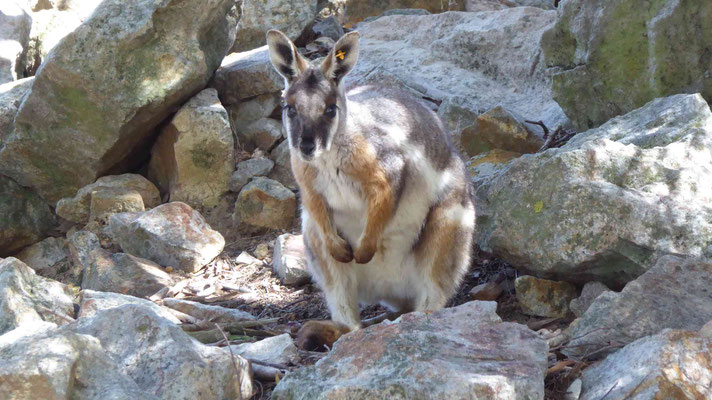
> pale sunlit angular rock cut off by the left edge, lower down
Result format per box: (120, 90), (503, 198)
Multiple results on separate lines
(0, 257), (74, 335)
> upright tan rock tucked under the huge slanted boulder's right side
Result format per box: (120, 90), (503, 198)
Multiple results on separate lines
(149, 89), (235, 210)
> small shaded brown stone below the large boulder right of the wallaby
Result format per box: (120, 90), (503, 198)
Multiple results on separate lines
(514, 276), (576, 317)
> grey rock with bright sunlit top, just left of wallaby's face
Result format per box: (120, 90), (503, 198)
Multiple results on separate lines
(213, 46), (284, 105)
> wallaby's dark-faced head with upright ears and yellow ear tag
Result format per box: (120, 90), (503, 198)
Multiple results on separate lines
(267, 30), (359, 162)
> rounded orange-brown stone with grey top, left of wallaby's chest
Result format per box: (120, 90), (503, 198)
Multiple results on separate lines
(234, 177), (297, 229)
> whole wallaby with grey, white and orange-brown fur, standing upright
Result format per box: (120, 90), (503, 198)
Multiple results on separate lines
(267, 30), (475, 348)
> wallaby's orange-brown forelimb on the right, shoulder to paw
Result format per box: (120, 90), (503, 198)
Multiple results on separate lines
(344, 135), (395, 264)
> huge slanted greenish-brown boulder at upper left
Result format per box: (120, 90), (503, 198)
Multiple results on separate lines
(0, 0), (241, 202)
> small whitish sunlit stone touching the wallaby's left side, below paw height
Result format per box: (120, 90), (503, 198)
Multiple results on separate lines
(272, 233), (311, 286)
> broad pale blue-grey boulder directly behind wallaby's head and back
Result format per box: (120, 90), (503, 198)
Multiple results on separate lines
(346, 8), (567, 143)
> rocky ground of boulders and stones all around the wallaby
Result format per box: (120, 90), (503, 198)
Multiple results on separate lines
(0, 0), (712, 400)
